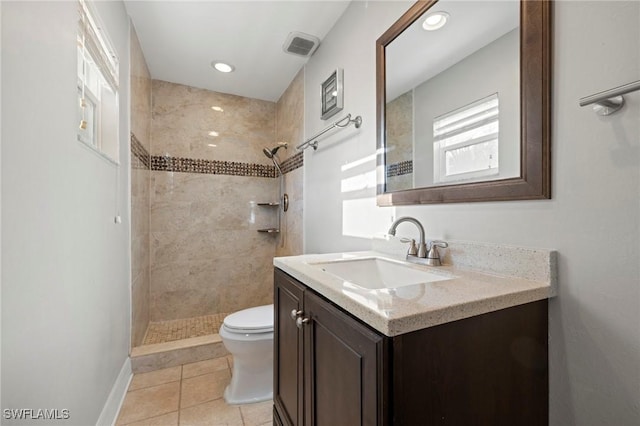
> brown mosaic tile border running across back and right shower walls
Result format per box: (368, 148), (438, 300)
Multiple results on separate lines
(149, 150), (304, 178)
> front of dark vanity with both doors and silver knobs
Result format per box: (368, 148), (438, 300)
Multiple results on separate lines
(274, 270), (386, 426)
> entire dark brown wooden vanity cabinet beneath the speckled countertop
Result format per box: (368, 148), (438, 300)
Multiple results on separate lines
(274, 269), (548, 426)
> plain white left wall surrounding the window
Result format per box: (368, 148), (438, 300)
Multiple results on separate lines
(2, 1), (130, 425)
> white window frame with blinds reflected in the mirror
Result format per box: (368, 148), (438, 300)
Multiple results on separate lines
(433, 93), (500, 183)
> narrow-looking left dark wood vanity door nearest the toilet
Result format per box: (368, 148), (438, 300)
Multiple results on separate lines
(273, 269), (304, 426)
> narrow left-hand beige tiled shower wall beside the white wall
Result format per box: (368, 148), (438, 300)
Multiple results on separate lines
(130, 28), (151, 346)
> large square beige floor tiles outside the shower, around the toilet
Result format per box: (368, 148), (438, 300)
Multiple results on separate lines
(116, 357), (273, 426)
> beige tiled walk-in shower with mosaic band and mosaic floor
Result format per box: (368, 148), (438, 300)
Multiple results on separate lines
(131, 33), (304, 371)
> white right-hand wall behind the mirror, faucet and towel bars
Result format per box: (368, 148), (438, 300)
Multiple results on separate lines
(304, 1), (640, 426)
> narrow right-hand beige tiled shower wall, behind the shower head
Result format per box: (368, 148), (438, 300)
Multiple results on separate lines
(276, 68), (304, 256)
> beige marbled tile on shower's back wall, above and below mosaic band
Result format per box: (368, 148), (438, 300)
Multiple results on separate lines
(149, 81), (278, 321)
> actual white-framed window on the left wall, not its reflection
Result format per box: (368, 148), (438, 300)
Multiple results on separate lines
(77, 0), (119, 162)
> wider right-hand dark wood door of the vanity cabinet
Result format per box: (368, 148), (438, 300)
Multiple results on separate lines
(304, 291), (386, 426)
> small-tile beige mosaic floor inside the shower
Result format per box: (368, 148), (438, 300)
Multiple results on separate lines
(142, 313), (228, 345)
